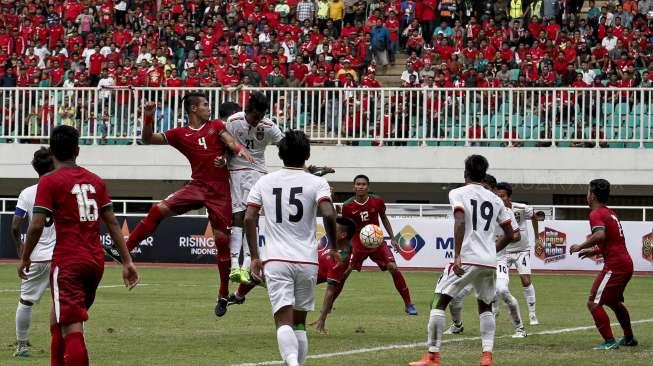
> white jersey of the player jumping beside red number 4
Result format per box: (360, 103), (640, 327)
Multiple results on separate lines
(226, 112), (284, 173)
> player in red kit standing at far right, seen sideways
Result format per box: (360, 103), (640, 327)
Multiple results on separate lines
(569, 179), (637, 350)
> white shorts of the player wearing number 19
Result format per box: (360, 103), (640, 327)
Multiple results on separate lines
(435, 264), (496, 304)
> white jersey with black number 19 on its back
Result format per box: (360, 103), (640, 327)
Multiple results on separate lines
(449, 184), (511, 268)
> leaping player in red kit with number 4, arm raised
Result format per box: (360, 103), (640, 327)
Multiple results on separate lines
(127, 93), (253, 316)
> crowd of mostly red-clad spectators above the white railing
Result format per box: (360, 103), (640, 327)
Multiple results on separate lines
(0, 0), (653, 87)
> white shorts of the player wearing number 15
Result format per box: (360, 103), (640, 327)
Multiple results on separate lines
(263, 261), (317, 314)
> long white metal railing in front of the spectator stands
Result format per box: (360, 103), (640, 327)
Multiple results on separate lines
(0, 88), (653, 148)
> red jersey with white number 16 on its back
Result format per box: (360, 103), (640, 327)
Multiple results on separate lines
(34, 166), (111, 267)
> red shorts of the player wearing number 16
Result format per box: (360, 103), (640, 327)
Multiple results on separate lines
(50, 261), (104, 325)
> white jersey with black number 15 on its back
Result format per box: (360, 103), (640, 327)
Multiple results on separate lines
(247, 168), (331, 264)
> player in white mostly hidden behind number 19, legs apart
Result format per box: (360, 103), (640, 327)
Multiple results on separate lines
(444, 174), (527, 338)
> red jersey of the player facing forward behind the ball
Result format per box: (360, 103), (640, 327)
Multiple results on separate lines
(342, 194), (385, 252)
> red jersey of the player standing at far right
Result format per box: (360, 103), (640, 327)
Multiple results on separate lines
(590, 206), (633, 273)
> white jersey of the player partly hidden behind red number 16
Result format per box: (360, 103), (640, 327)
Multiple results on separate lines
(14, 184), (57, 262)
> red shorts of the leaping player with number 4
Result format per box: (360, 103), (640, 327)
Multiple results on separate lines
(163, 180), (232, 235)
